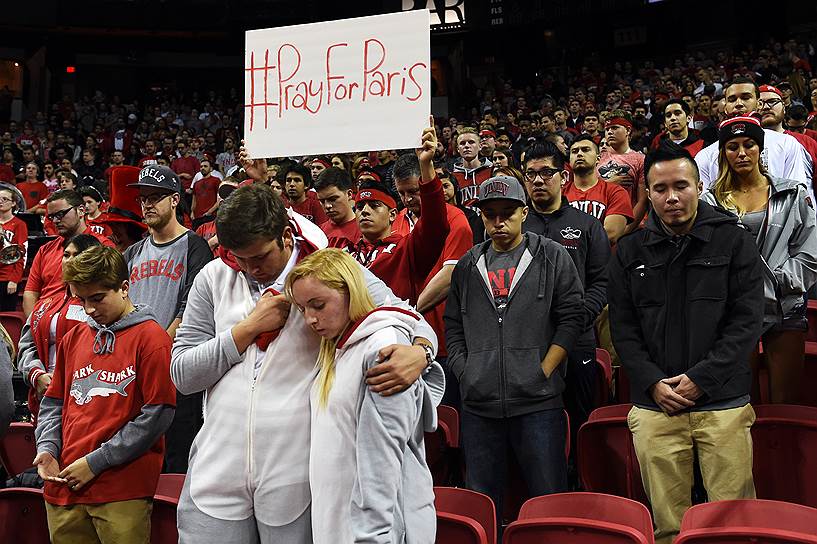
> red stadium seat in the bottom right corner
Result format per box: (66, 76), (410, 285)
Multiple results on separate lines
(675, 499), (817, 544)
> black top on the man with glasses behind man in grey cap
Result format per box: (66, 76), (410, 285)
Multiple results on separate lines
(522, 196), (610, 348)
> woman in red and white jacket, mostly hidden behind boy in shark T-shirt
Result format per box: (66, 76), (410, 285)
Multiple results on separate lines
(17, 234), (100, 425)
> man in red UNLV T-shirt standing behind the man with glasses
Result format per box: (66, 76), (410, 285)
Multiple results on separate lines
(562, 134), (633, 244)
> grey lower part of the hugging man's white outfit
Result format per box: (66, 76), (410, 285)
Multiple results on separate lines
(176, 478), (312, 544)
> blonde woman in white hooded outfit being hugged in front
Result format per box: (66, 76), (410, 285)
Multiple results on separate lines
(286, 249), (436, 544)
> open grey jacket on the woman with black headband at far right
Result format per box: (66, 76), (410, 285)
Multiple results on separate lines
(701, 175), (817, 329)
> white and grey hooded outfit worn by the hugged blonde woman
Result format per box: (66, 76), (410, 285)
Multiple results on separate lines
(309, 308), (437, 544)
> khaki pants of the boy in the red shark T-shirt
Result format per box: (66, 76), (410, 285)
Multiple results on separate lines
(45, 499), (153, 544)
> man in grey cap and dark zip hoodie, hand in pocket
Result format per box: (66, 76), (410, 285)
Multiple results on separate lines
(445, 176), (585, 528)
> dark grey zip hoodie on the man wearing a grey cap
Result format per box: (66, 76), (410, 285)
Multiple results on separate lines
(444, 232), (584, 418)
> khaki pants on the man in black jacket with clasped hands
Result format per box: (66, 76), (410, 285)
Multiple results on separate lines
(627, 404), (755, 544)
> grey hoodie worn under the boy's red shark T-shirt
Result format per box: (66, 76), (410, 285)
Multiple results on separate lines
(35, 306), (176, 475)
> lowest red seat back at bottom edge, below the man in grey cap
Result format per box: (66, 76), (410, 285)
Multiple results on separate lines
(502, 517), (653, 544)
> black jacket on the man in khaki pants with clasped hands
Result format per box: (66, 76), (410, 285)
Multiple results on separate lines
(607, 201), (763, 409)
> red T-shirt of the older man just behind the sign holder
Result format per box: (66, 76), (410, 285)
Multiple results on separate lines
(391, 204), (474, 357)
